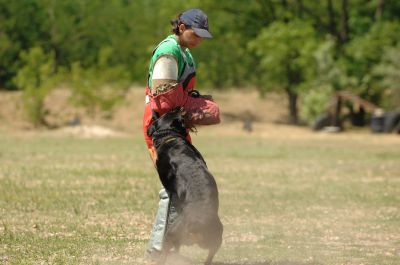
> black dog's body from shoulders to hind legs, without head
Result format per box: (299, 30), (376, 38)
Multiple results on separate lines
(157, 138), (223, 264)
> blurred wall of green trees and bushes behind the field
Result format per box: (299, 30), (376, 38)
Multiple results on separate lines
(0, 0), (400, 130)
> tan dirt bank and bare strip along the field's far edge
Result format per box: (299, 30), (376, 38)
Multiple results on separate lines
(0, 86), (398, 142)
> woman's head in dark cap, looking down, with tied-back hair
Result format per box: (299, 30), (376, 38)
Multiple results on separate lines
(171, 9), (212, 48)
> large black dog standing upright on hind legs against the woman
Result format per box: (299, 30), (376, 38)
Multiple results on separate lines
(147, 109), (223, 265)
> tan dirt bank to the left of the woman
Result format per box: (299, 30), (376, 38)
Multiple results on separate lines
(0, 88), (144, 136)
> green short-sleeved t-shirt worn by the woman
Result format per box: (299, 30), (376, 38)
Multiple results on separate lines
(147, 35), (195, 88)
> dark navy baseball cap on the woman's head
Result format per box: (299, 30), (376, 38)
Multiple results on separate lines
(180, 8), (212, 38)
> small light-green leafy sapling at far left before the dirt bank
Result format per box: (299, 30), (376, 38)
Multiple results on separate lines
(15, 47), (54, 126)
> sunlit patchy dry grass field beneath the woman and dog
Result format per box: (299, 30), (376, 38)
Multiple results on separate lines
(0, 125), (400, 265)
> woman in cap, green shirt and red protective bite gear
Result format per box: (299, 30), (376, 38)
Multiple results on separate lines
(143, 9), (220, 259)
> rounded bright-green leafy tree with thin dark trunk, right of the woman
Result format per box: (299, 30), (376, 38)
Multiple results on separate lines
(249, 20), (317, 124)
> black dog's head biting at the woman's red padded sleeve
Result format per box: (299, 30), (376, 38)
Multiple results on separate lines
(147, 108), (186, 137)
